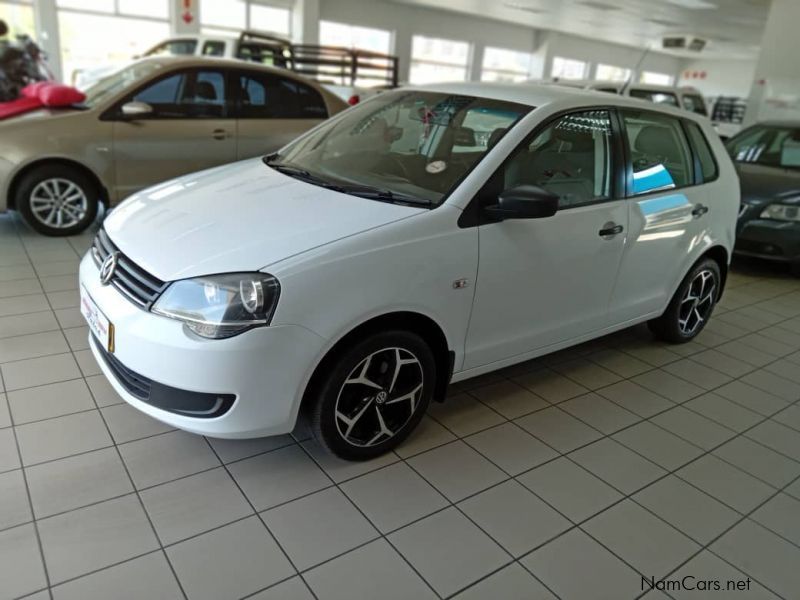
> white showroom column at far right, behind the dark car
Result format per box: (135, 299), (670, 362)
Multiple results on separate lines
(744, 0), (800, 125)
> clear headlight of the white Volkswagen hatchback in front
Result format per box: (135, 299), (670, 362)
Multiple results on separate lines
(152, 273), (280, 339)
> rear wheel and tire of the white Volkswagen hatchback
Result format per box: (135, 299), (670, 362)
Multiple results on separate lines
(647, 258), (722, 344)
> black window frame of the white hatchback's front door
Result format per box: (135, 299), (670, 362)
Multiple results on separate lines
(458, 104), (628, 229)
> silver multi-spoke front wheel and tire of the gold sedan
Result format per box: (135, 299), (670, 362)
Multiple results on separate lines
(14, 164), (100, 236)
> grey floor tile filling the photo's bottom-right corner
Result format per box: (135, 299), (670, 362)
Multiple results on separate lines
(711, 520), (800, 598)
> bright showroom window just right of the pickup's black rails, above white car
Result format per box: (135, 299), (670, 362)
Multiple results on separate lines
(410, 35), (470, 83)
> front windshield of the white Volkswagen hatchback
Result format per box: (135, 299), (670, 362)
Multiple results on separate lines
(268, 90), (532, 205)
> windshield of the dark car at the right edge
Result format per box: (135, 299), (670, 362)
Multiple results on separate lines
(727, 124), (800, 169)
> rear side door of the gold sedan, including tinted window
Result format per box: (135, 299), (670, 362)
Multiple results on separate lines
(233, 70), (328, 159)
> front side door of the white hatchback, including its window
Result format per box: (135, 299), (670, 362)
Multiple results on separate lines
(465, 109), (628, 369)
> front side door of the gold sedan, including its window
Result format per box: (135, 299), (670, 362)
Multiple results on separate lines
(113, 69), (236, 199)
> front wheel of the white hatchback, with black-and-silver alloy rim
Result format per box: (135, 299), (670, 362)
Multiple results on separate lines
(311, 331), (436, 461)
